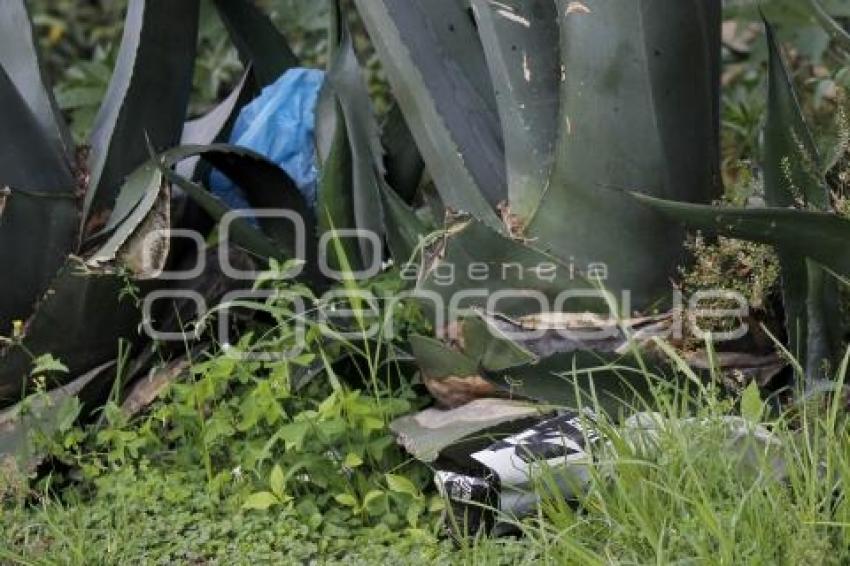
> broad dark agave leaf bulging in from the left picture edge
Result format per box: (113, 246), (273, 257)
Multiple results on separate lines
(0, 68), (79, 334)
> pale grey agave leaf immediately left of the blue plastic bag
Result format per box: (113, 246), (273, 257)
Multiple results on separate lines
(176, 70), (253, 179)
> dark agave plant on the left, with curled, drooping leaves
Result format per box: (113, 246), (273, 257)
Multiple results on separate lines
(0, 0), (338, 432)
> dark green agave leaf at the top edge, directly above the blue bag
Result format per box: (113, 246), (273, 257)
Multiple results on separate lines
(215, 0), (299, 87)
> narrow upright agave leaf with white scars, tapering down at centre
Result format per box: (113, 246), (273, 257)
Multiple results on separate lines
(472, 0), (567, 223)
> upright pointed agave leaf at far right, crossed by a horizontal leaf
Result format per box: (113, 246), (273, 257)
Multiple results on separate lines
(764, 22), (842, 384)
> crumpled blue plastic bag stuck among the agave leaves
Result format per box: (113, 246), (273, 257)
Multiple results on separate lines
(210, 69), (325, 213)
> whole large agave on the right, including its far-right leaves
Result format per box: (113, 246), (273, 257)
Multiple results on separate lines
(340, 0), (850, 418)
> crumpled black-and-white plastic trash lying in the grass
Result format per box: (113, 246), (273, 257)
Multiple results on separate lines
(434, 410), (786, 539)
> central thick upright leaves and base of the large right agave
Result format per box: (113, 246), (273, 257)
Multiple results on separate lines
(344, 0), (721, 410)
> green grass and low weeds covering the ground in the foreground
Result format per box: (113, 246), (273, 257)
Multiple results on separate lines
(0, 346), (850, 565)
